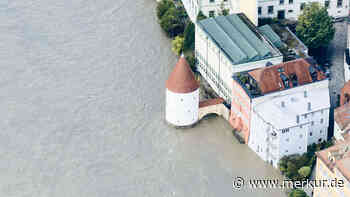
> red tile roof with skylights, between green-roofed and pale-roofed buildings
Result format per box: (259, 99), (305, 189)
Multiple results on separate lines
(249, 59), (326, 94)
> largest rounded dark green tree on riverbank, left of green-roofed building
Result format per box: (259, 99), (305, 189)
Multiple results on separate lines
(160, 7), (185, 38)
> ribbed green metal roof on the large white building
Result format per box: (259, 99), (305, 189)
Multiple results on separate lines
(198, 14), (272, 64)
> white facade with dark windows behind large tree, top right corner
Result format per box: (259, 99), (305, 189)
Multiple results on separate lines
(258, 0), (349, 20)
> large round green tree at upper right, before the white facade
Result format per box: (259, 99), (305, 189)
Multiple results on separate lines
(296, 2), (335, 48)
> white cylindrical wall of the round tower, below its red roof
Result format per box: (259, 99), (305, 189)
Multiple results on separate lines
(166, 89), (199, 126)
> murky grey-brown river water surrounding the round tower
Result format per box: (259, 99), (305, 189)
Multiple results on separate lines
(0, 0), (283, 197)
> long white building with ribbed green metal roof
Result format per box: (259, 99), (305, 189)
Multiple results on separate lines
(195, 14), (283, 103)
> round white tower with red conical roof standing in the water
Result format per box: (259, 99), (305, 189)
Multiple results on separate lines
(165, 55), (199, 126)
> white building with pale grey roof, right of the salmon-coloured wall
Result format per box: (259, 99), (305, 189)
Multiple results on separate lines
(248, 77), (330, 167)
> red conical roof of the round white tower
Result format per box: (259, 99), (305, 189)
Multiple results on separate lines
(166, 55), (199, 93)
